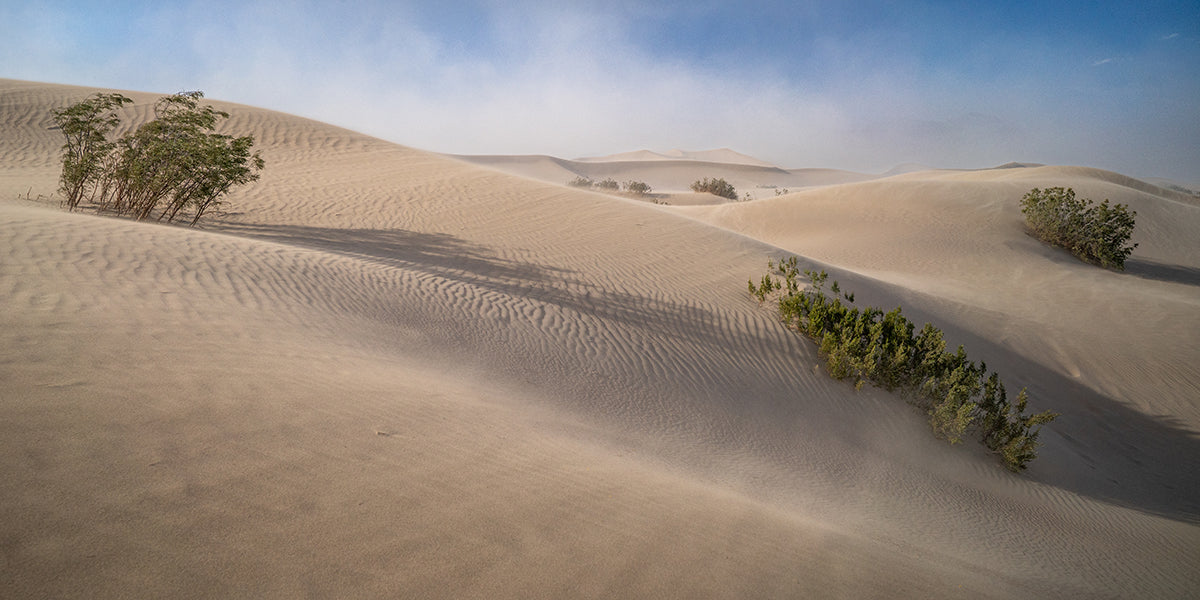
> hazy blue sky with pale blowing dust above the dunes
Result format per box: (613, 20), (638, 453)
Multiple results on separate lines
(7, 0), (1200, 182)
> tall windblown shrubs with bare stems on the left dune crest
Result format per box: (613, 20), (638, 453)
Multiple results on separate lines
(53, 91), (264, 226)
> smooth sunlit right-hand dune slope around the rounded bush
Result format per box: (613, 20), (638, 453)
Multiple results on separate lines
(680, 167), (1200, 428)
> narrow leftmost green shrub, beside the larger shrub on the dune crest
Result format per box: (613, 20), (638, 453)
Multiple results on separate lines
(50, 94), (133, 210)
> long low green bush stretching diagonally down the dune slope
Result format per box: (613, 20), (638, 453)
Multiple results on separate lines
(749, 257), (1058, 472)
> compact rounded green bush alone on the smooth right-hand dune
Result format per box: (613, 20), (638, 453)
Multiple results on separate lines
(1021, 187), (1138, 270)
